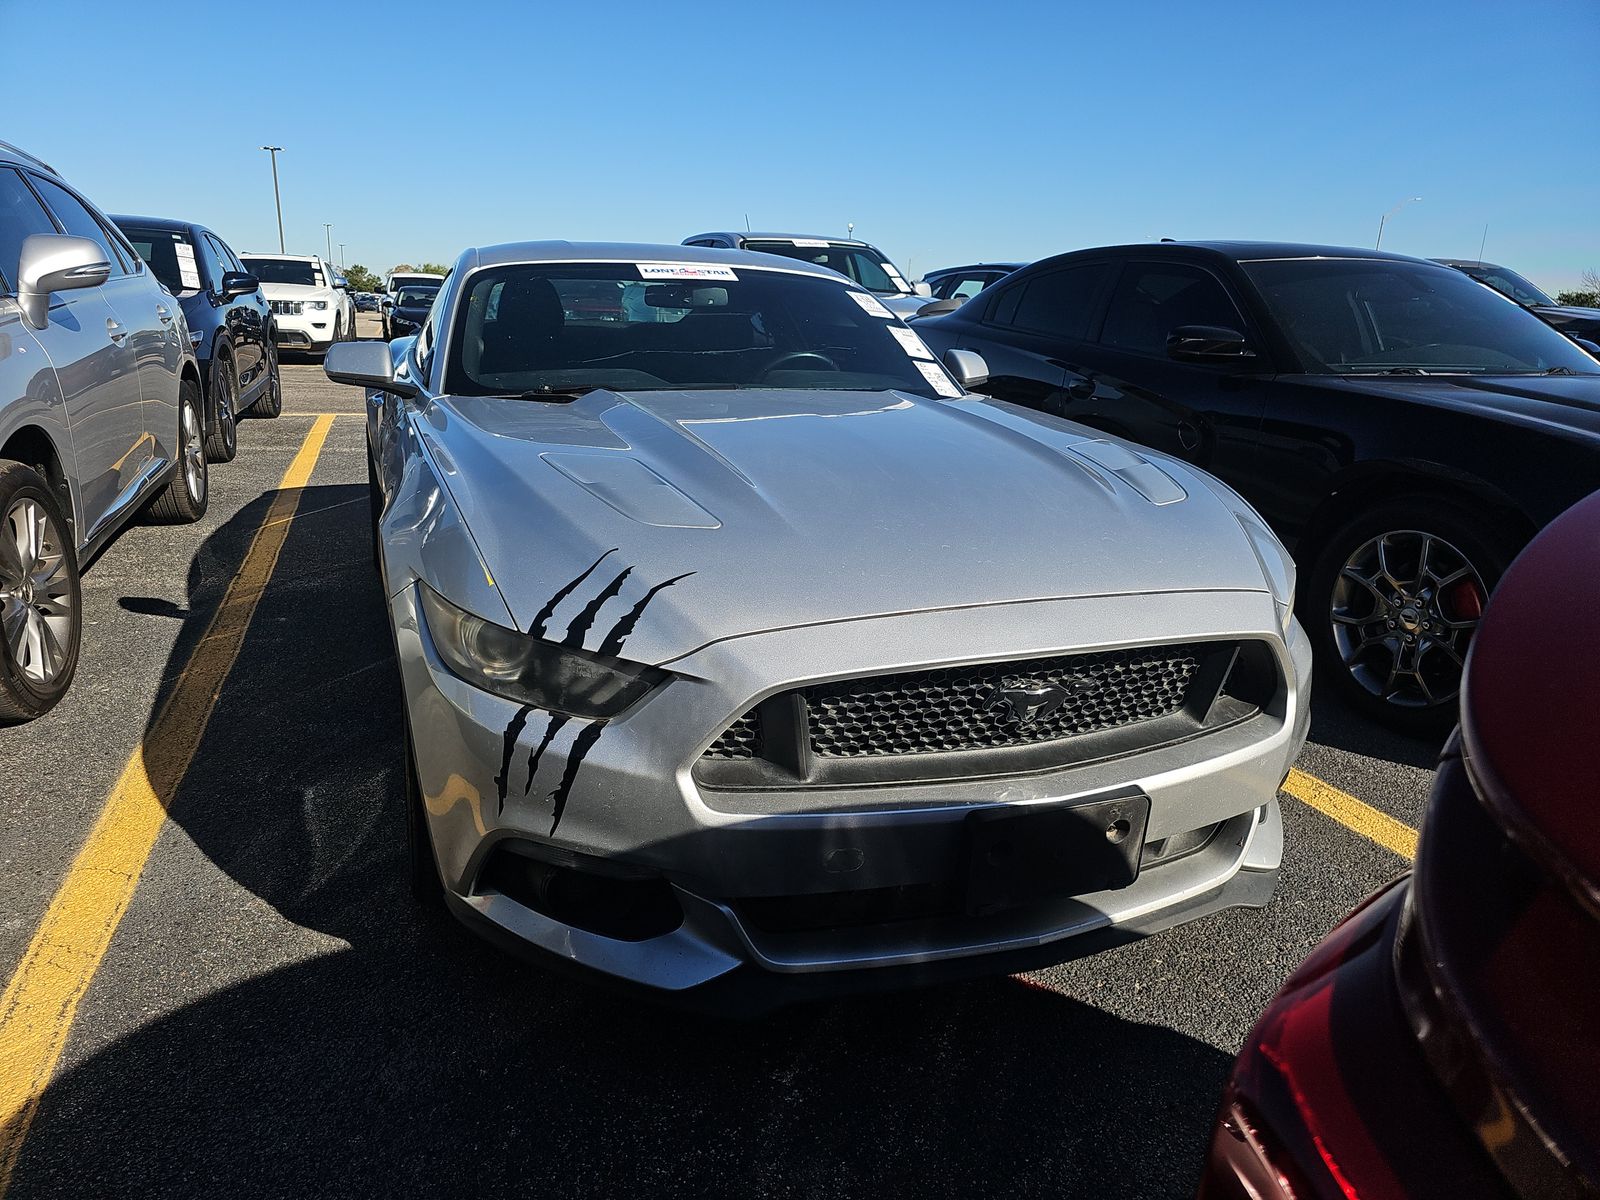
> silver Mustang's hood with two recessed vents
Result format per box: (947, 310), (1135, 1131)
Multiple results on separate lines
(418, 390), (1267, 664)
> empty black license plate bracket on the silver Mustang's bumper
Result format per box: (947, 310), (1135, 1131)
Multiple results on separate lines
(966, 789), (1150, 917)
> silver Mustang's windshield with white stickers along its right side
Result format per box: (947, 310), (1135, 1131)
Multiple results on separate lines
(445, 262), (960, 397)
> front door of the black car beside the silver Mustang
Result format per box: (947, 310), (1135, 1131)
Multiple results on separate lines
(1058, 258), (1272, 485)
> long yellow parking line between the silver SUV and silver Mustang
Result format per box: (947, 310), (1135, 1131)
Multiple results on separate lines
(0, 416), (333, 1197)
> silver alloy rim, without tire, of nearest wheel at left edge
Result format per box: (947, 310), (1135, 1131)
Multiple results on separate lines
(0, 496), (75, 685)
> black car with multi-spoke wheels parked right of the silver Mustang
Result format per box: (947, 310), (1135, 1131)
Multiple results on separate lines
(917, 242), (1600, 730)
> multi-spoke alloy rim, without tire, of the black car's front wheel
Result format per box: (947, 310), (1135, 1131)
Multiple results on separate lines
(1330, 530), (1488, 709)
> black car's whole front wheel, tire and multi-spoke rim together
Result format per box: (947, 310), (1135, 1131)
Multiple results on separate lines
(1301, 496), (1515, 733)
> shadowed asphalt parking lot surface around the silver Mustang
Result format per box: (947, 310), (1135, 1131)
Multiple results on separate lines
(0, 317), (1437, 1200)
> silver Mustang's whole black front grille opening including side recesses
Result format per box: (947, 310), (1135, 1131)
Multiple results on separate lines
(696, 642), (1260, 789)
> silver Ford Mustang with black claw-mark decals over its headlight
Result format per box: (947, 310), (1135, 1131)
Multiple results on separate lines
(326, 242), (1310, 1005)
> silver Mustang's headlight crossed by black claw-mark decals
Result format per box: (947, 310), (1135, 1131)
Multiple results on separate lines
(419, 584), (667, 720)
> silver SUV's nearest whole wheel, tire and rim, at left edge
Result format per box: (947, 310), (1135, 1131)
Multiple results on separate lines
(0, 461), (83, 725)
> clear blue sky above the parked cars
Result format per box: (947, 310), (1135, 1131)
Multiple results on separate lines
(0, 0), (1600, 290)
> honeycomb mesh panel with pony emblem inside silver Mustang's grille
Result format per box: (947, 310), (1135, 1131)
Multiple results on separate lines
(805, 646), (1200, 758)
